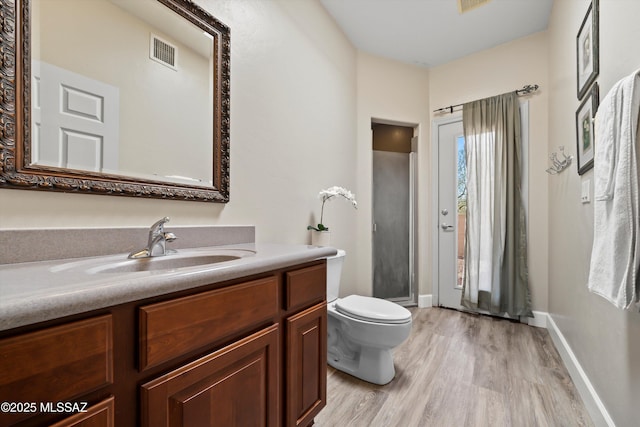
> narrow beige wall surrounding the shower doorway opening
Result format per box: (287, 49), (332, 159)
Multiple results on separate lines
(352, 52), (431, 295)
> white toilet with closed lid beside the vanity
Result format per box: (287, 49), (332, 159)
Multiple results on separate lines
(327, 250), (411, 385)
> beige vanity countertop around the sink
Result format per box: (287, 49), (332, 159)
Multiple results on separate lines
(0, 243), (336, 331)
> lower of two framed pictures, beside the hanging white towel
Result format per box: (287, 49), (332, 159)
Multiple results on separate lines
(576, 82), (600, 175)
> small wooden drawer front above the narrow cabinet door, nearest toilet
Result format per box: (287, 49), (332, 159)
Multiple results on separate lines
(284, 263), (327, 310)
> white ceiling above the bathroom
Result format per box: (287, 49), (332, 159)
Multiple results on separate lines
(320, 0), (553, 67)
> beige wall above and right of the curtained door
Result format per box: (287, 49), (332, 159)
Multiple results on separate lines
(428, 32), (550, 311)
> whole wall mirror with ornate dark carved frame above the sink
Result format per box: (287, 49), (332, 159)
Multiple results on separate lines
(0, 0), (230, 203)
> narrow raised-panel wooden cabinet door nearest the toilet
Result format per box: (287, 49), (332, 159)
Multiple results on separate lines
(285, 303), (327, 426)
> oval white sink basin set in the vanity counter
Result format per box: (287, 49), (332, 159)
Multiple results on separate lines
(51, 249), (255, 274)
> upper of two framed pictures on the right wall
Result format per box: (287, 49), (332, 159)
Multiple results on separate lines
(576, 0), (600, 99)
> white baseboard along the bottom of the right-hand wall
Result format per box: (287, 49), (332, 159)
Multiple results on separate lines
(534, 312), (615, 427)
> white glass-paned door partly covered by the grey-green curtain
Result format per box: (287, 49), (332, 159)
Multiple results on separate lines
(436, 118), (466, 309)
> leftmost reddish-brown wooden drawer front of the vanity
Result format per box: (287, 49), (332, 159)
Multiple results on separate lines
(0, 315), (113, 425)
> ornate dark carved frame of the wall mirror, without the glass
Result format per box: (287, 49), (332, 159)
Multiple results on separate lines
(0, 0), (231, 203)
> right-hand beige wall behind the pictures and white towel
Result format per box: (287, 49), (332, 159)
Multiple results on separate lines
(548, 0), (640, 426)
